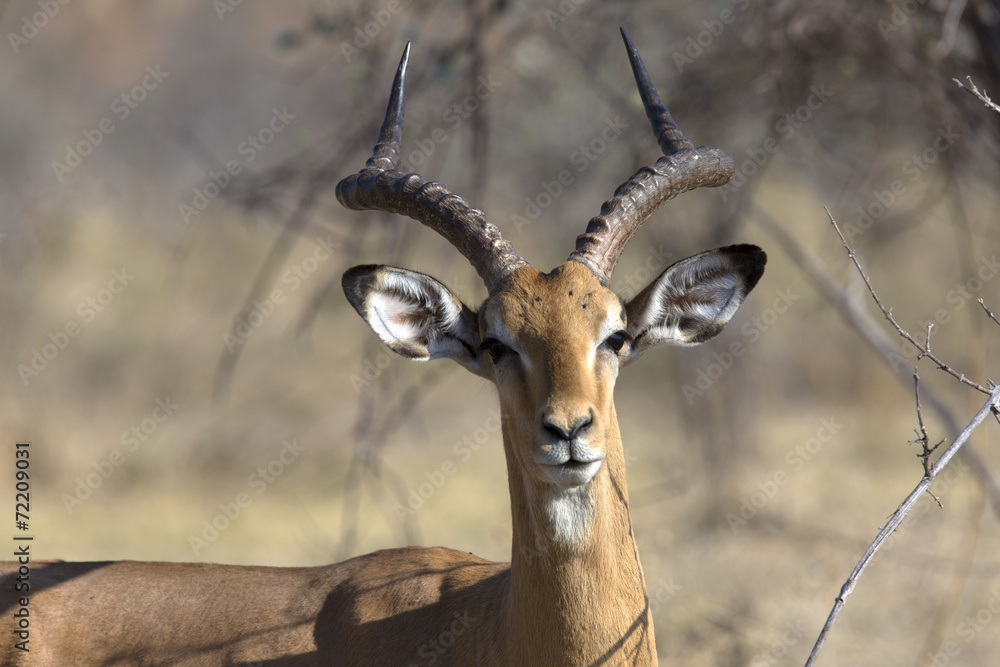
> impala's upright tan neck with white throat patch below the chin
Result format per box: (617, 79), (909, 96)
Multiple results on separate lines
(503, 406), (656, 665)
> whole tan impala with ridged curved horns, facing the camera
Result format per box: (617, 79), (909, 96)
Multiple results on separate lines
(0, 31), (766, 667)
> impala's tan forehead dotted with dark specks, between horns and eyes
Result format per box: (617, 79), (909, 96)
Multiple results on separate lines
(483, 262), (624, 335)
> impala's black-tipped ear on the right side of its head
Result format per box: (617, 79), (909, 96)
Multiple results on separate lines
(626, 245), (767, 362)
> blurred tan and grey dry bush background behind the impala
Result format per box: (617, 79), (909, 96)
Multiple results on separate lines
(0, 0), (1000, 665)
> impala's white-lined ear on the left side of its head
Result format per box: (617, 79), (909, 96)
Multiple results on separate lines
(343, 264), (485, 375)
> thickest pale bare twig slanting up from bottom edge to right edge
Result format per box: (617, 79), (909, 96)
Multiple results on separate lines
(805, 385), (1000, 667)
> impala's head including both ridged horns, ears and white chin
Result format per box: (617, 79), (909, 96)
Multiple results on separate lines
(337, 31), (766, 512)
